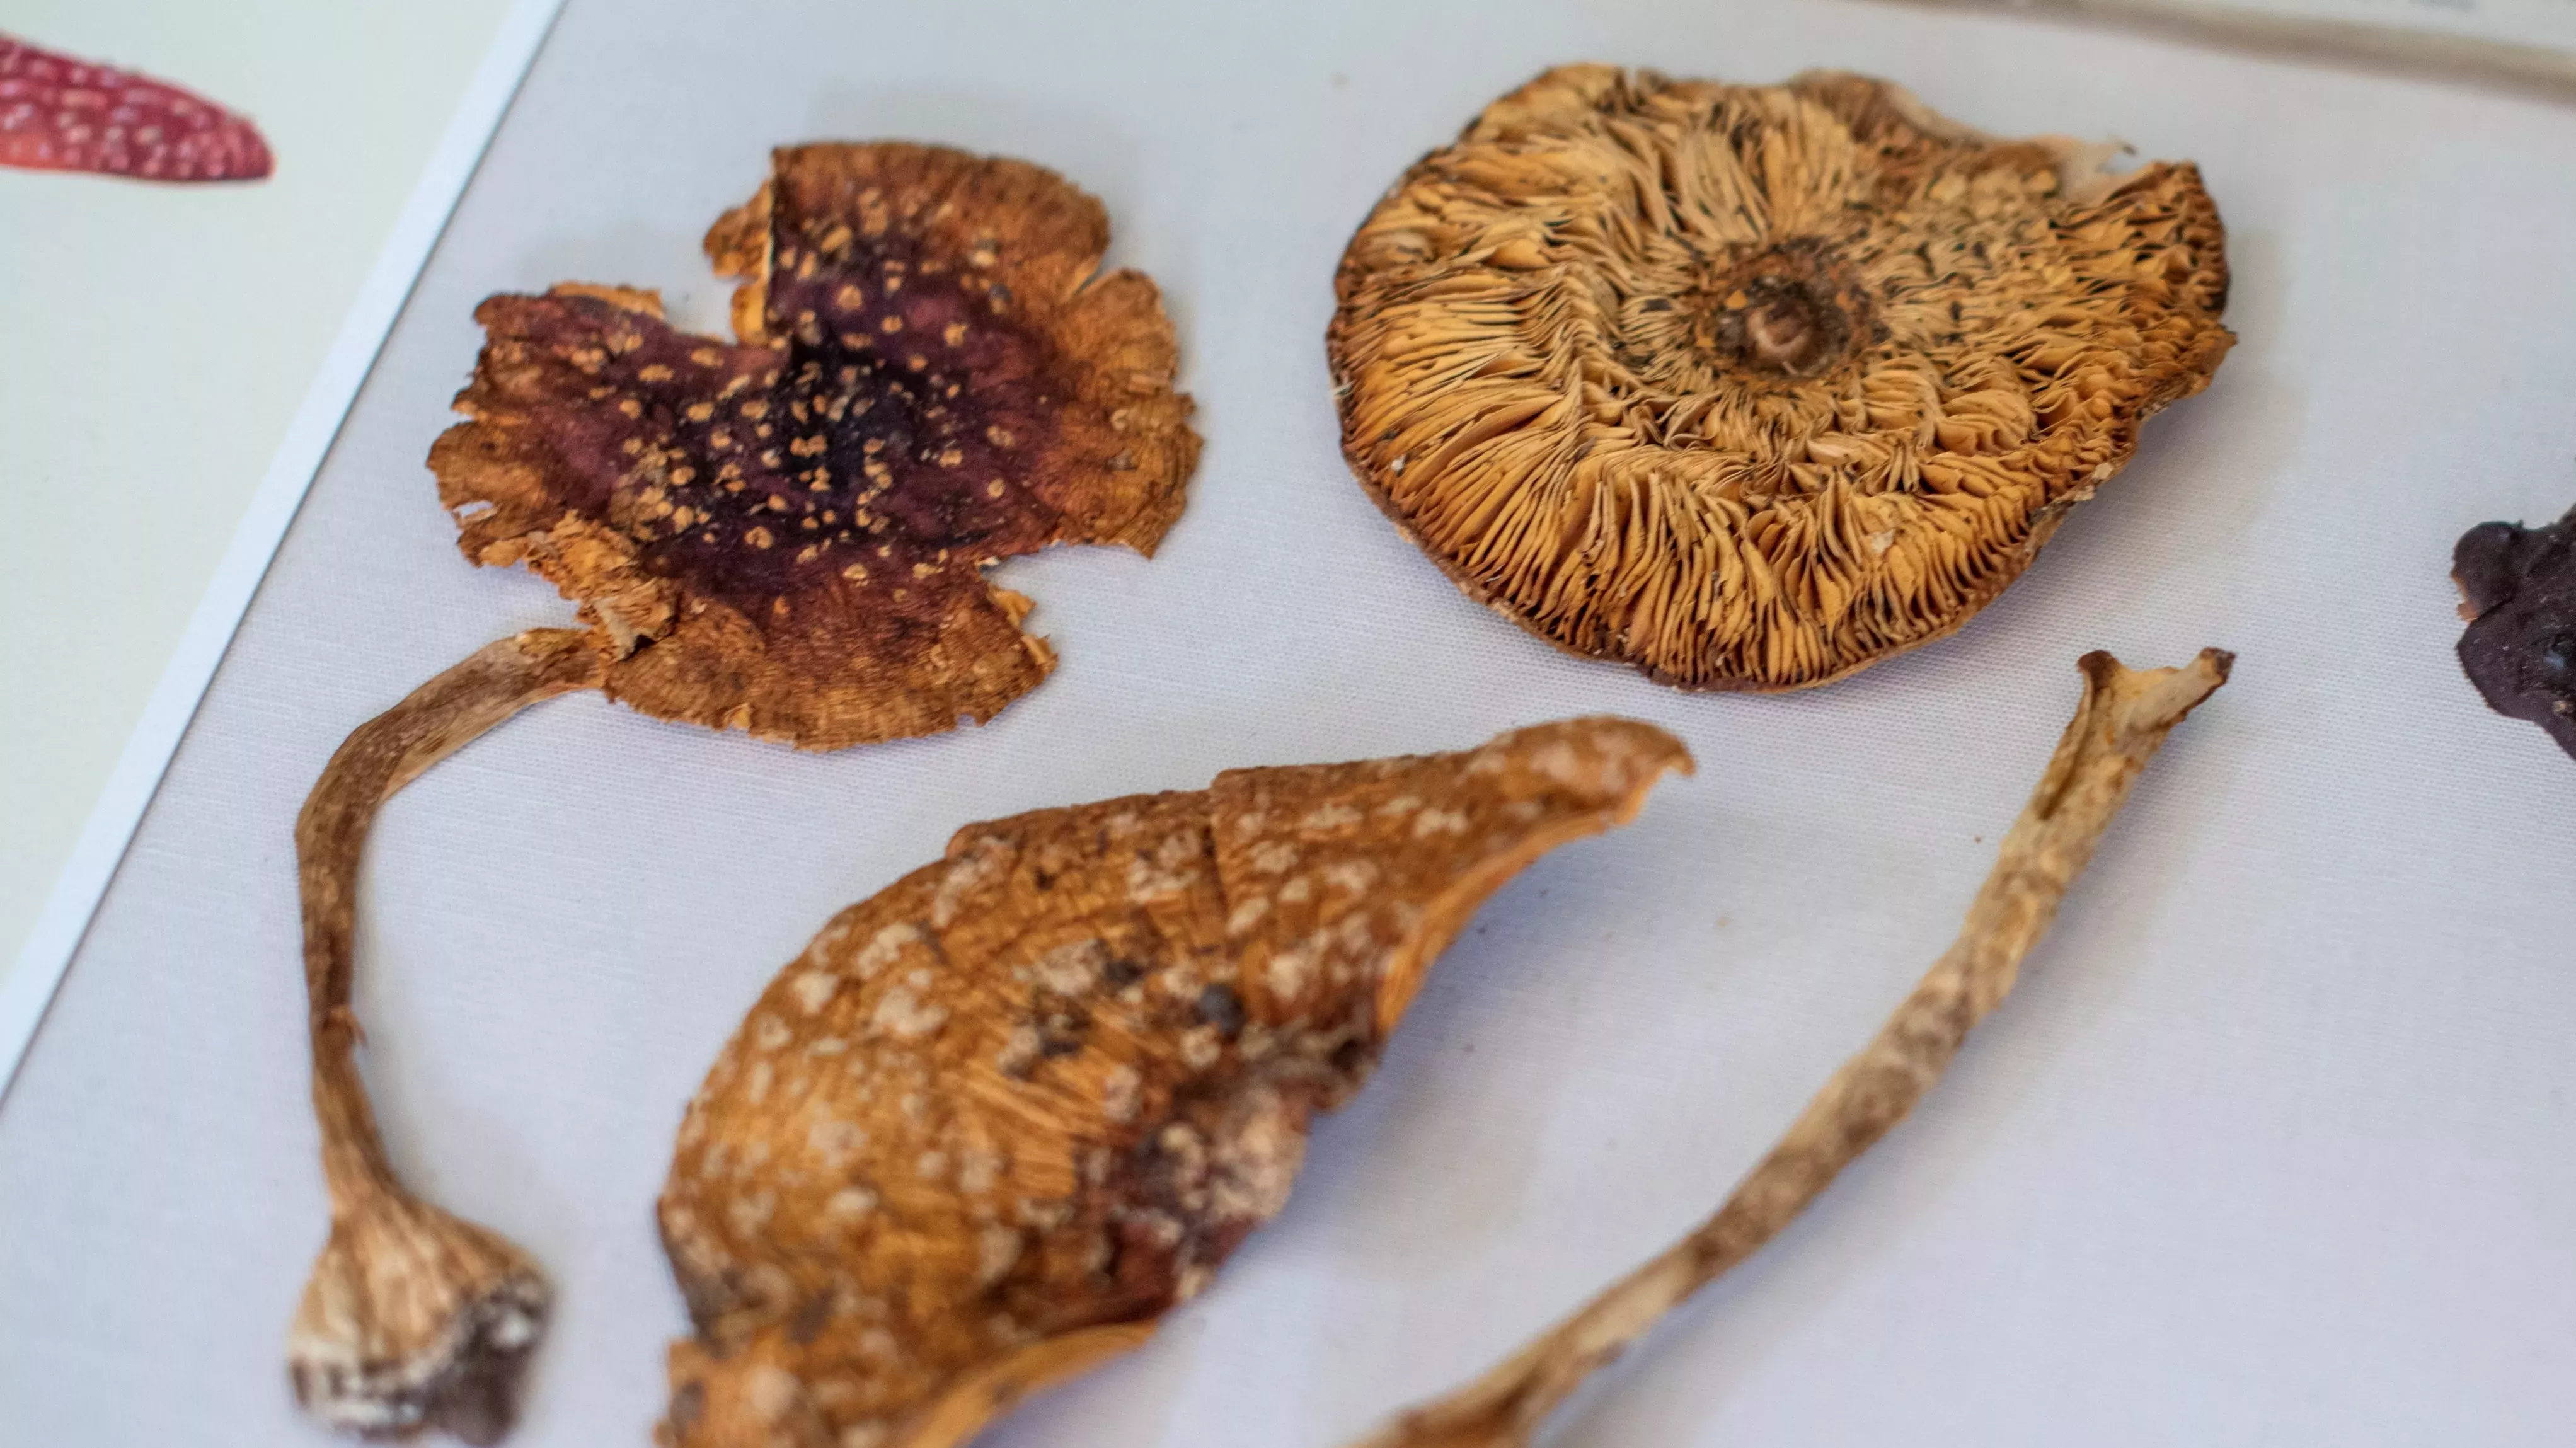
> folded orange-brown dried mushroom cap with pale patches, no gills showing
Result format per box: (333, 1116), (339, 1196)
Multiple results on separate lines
(662, 719), (1690, 1448)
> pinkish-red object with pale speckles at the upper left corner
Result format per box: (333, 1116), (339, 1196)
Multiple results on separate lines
(0, 36), (273, 180)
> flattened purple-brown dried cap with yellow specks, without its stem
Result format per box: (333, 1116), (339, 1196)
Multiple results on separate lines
(430, 144), (1198, 750)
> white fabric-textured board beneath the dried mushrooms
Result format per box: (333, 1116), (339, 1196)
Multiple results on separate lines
(0, 0), (2576, 1448)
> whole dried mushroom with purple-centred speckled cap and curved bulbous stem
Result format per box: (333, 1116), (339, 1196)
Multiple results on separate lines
(289, 144), (1198, 1440)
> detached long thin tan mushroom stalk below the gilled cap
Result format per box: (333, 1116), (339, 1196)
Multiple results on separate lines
(1352, 649), (2233, 1448)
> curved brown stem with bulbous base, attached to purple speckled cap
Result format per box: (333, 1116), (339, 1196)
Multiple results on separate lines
(286, 629), (601, 1443)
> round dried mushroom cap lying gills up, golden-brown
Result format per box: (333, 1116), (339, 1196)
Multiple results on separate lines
(1326, 64), (2233, 691)
